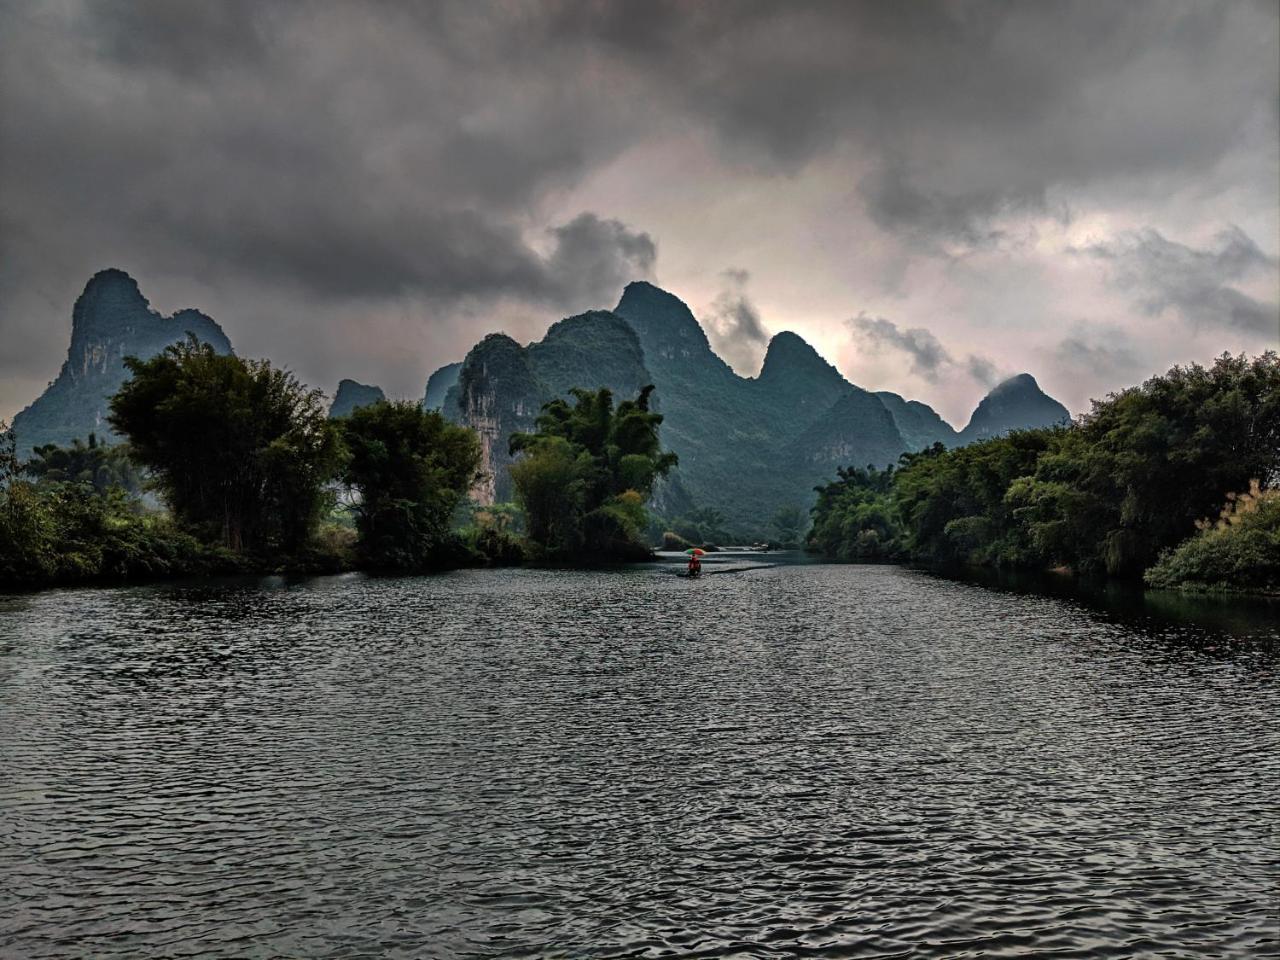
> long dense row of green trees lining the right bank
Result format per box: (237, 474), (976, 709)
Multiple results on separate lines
(809, 352), (1280, 591)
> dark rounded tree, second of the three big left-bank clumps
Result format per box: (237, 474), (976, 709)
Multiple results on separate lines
(337, 401), (480, 570)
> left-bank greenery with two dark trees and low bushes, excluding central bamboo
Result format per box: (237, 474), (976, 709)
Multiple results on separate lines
(0, 338), (494, 586)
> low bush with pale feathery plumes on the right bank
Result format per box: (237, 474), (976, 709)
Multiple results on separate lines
(1144, 480), (1280, 593)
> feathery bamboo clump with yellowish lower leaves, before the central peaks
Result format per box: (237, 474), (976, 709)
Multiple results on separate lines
(511, 387), (676, 559)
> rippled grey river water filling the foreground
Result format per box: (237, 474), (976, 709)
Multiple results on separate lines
(0, 558), (1280, 957)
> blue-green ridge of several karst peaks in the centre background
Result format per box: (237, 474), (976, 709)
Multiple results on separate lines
(440, 282), (1068, 532)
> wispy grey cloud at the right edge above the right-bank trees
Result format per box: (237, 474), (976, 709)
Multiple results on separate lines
(1080, 227), (1280, 334)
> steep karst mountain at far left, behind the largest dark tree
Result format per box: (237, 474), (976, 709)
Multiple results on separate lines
(13, 270), (232, 457)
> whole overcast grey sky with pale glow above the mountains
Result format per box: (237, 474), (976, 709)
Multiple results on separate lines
(0, 0), (1280, 425)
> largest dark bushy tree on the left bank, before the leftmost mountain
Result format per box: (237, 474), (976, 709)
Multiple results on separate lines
(110, 337), (338, 553)
